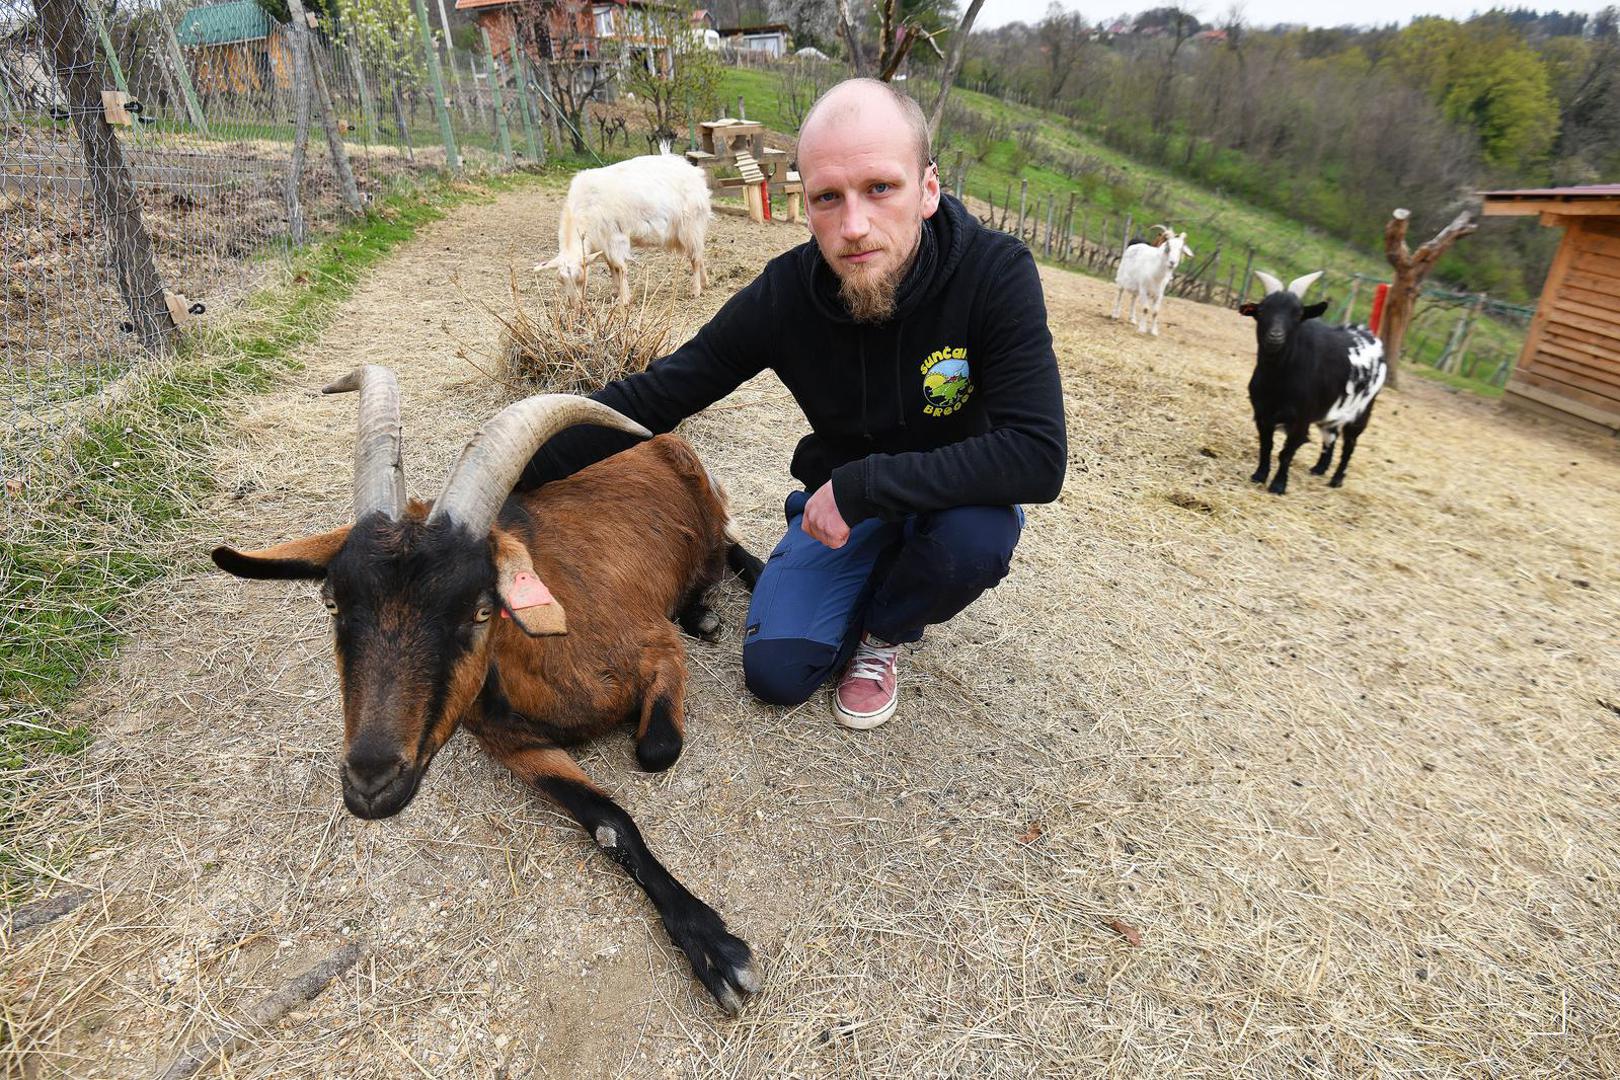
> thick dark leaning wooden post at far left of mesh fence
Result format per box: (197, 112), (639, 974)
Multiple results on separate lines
(34, 0), (175, 350)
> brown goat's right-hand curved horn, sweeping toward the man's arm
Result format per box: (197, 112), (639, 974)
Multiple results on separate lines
(428, 393), (653, 536)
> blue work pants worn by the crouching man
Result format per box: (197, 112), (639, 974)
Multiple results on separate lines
(742, 491), (1024, 704)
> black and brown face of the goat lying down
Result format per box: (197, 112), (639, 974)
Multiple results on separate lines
(321, 515), (499, 818)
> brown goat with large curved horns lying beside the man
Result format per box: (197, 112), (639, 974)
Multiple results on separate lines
(214, 364), (760, 1012)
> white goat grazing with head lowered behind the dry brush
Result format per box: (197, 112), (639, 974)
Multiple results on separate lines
(535, 152), (710, 304)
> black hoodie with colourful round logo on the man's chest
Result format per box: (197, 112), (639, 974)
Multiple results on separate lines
(520, 196), (1068, 525)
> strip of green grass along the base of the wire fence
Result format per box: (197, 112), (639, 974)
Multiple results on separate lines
(0, 162), (533, 904)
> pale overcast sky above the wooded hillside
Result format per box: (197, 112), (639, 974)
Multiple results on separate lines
(974, 0), (1615, 29)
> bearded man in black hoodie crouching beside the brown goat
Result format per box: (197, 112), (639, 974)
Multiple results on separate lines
(522, 79), (1068, 729)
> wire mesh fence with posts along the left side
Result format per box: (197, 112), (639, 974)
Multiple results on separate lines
(0, 0), (557, 523)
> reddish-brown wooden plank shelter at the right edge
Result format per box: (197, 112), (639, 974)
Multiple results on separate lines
(1482, 185), (1620, 434)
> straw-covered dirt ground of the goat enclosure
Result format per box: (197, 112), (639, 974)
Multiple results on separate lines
(5, 191), (1620, 1080)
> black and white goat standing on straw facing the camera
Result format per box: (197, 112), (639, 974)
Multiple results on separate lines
(1238, 270), (1388, 495)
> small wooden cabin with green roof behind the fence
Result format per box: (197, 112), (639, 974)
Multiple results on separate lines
(175, 0), (293, 96)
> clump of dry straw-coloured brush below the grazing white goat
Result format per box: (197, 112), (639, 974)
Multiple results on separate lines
(486, 270), (680, 393)
